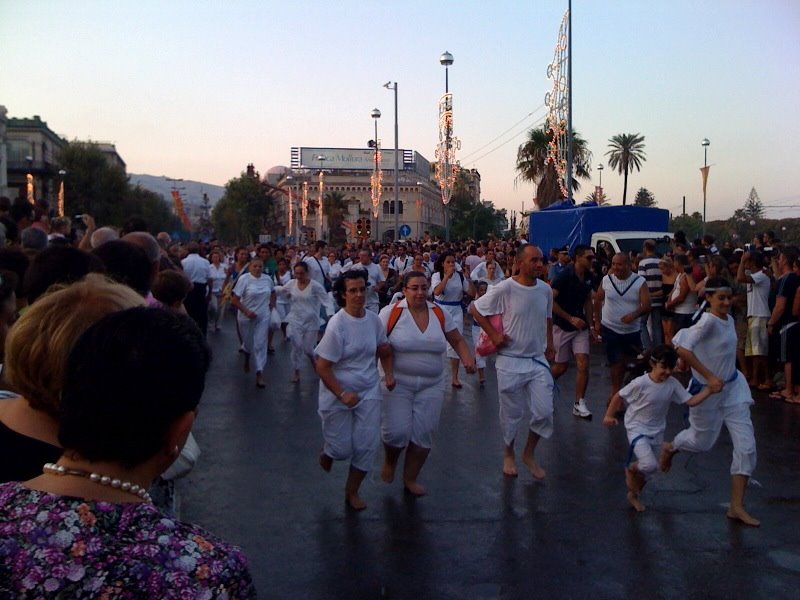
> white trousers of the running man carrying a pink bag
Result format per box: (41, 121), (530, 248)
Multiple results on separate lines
(497, 361), (553, 446)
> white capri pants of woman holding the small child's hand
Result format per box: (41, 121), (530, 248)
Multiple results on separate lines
(672, 373), (757, 477)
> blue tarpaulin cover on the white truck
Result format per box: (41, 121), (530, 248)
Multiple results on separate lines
(528, 203), (669, 255)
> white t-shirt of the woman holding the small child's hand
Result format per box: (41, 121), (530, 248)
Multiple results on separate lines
(672, 312), (736, 383)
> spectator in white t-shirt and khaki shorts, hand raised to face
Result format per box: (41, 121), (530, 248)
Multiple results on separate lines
(736, 252), (772, 390)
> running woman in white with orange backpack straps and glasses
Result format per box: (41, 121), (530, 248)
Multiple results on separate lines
(379, 271), (475, 496)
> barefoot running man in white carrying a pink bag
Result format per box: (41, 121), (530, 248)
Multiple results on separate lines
(469, 245), (555, 480)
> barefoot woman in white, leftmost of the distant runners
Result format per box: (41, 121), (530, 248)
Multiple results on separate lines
(231, 257), (275, 388)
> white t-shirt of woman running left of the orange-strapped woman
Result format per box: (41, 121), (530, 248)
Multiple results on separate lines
(314, 310), (387, 410)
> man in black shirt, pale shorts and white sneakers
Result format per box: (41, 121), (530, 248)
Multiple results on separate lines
(550, 244), (595, 419)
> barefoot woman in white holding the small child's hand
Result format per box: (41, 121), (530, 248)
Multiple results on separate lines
(660, 277), (759, 527)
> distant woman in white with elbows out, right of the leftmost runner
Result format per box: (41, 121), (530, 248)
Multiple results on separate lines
(275, 262), (328, 383)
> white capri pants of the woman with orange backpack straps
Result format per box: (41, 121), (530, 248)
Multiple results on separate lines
(381, 373), (444, 448)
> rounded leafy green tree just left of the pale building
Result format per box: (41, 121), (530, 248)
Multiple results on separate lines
(211, 173), (273, 244)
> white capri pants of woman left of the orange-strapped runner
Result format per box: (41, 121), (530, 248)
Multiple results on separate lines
(318, 398), (381, 472)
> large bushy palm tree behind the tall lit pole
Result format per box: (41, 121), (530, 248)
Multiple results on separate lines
(516, 125), (592, 208)
